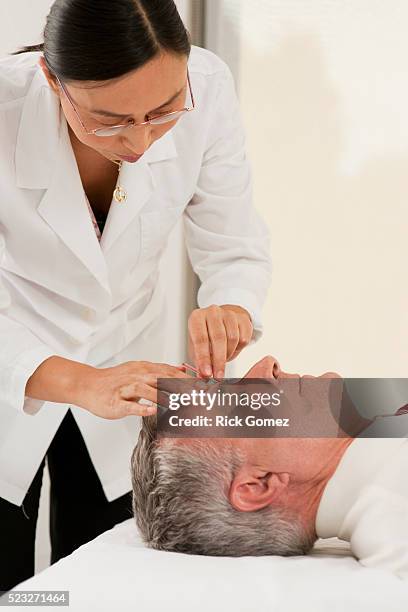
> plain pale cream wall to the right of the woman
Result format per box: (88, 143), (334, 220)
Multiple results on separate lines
(207, 0), (408, 377)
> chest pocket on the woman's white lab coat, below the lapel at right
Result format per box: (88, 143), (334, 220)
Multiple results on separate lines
(139, 205), (185, 262)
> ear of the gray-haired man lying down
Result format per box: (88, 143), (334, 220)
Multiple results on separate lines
(229, 465), (290, 512)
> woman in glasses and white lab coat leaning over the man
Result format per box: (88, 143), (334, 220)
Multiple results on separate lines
(0, 0), (270, 590)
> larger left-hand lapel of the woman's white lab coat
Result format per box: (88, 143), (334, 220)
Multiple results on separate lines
(15, 67), (110, 293)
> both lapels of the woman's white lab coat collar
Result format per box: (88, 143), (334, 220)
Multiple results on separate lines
(15, 66), (177, 293)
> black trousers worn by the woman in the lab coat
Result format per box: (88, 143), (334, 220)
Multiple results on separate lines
(0, 410), (133, 591)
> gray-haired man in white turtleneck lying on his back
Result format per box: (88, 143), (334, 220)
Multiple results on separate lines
(132, 356), (408, 579)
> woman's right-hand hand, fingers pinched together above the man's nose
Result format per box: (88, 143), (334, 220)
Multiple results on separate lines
(188, 304), (253, 378)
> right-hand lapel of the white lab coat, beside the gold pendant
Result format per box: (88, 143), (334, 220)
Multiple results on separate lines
(101, 131), (177, 253)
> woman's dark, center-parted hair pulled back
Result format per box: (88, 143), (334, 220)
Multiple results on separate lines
(11, 0), (191, 82)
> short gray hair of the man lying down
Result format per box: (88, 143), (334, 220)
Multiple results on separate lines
(131, 416), (315, 557)
